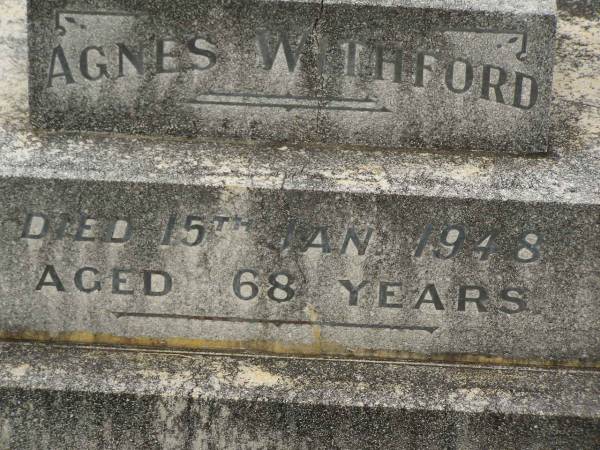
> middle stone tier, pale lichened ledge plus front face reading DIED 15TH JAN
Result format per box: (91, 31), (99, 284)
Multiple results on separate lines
(0, 3), (600, 366)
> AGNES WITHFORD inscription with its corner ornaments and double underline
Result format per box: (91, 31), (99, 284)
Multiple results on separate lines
(47, 17), (539, 112)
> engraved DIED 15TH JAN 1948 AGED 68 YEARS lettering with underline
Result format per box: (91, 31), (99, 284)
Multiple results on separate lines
(20, 212), (544, 334)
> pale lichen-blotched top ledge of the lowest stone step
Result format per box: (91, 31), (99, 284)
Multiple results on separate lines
(0, 342), (600, 421)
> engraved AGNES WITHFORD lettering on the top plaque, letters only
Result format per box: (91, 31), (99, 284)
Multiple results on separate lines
(47, 29), (540, 110)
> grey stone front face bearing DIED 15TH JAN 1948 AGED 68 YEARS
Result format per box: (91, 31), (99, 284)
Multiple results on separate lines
(0, 146), (600, 367)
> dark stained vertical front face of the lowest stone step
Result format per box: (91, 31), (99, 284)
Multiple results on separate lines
(2, 389), (600, 449)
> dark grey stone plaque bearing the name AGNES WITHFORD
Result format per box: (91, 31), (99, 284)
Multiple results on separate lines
(29, 0), (556, 153)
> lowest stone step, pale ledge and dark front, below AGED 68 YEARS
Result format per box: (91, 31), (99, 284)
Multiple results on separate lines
(0, 343), (600, 449)
